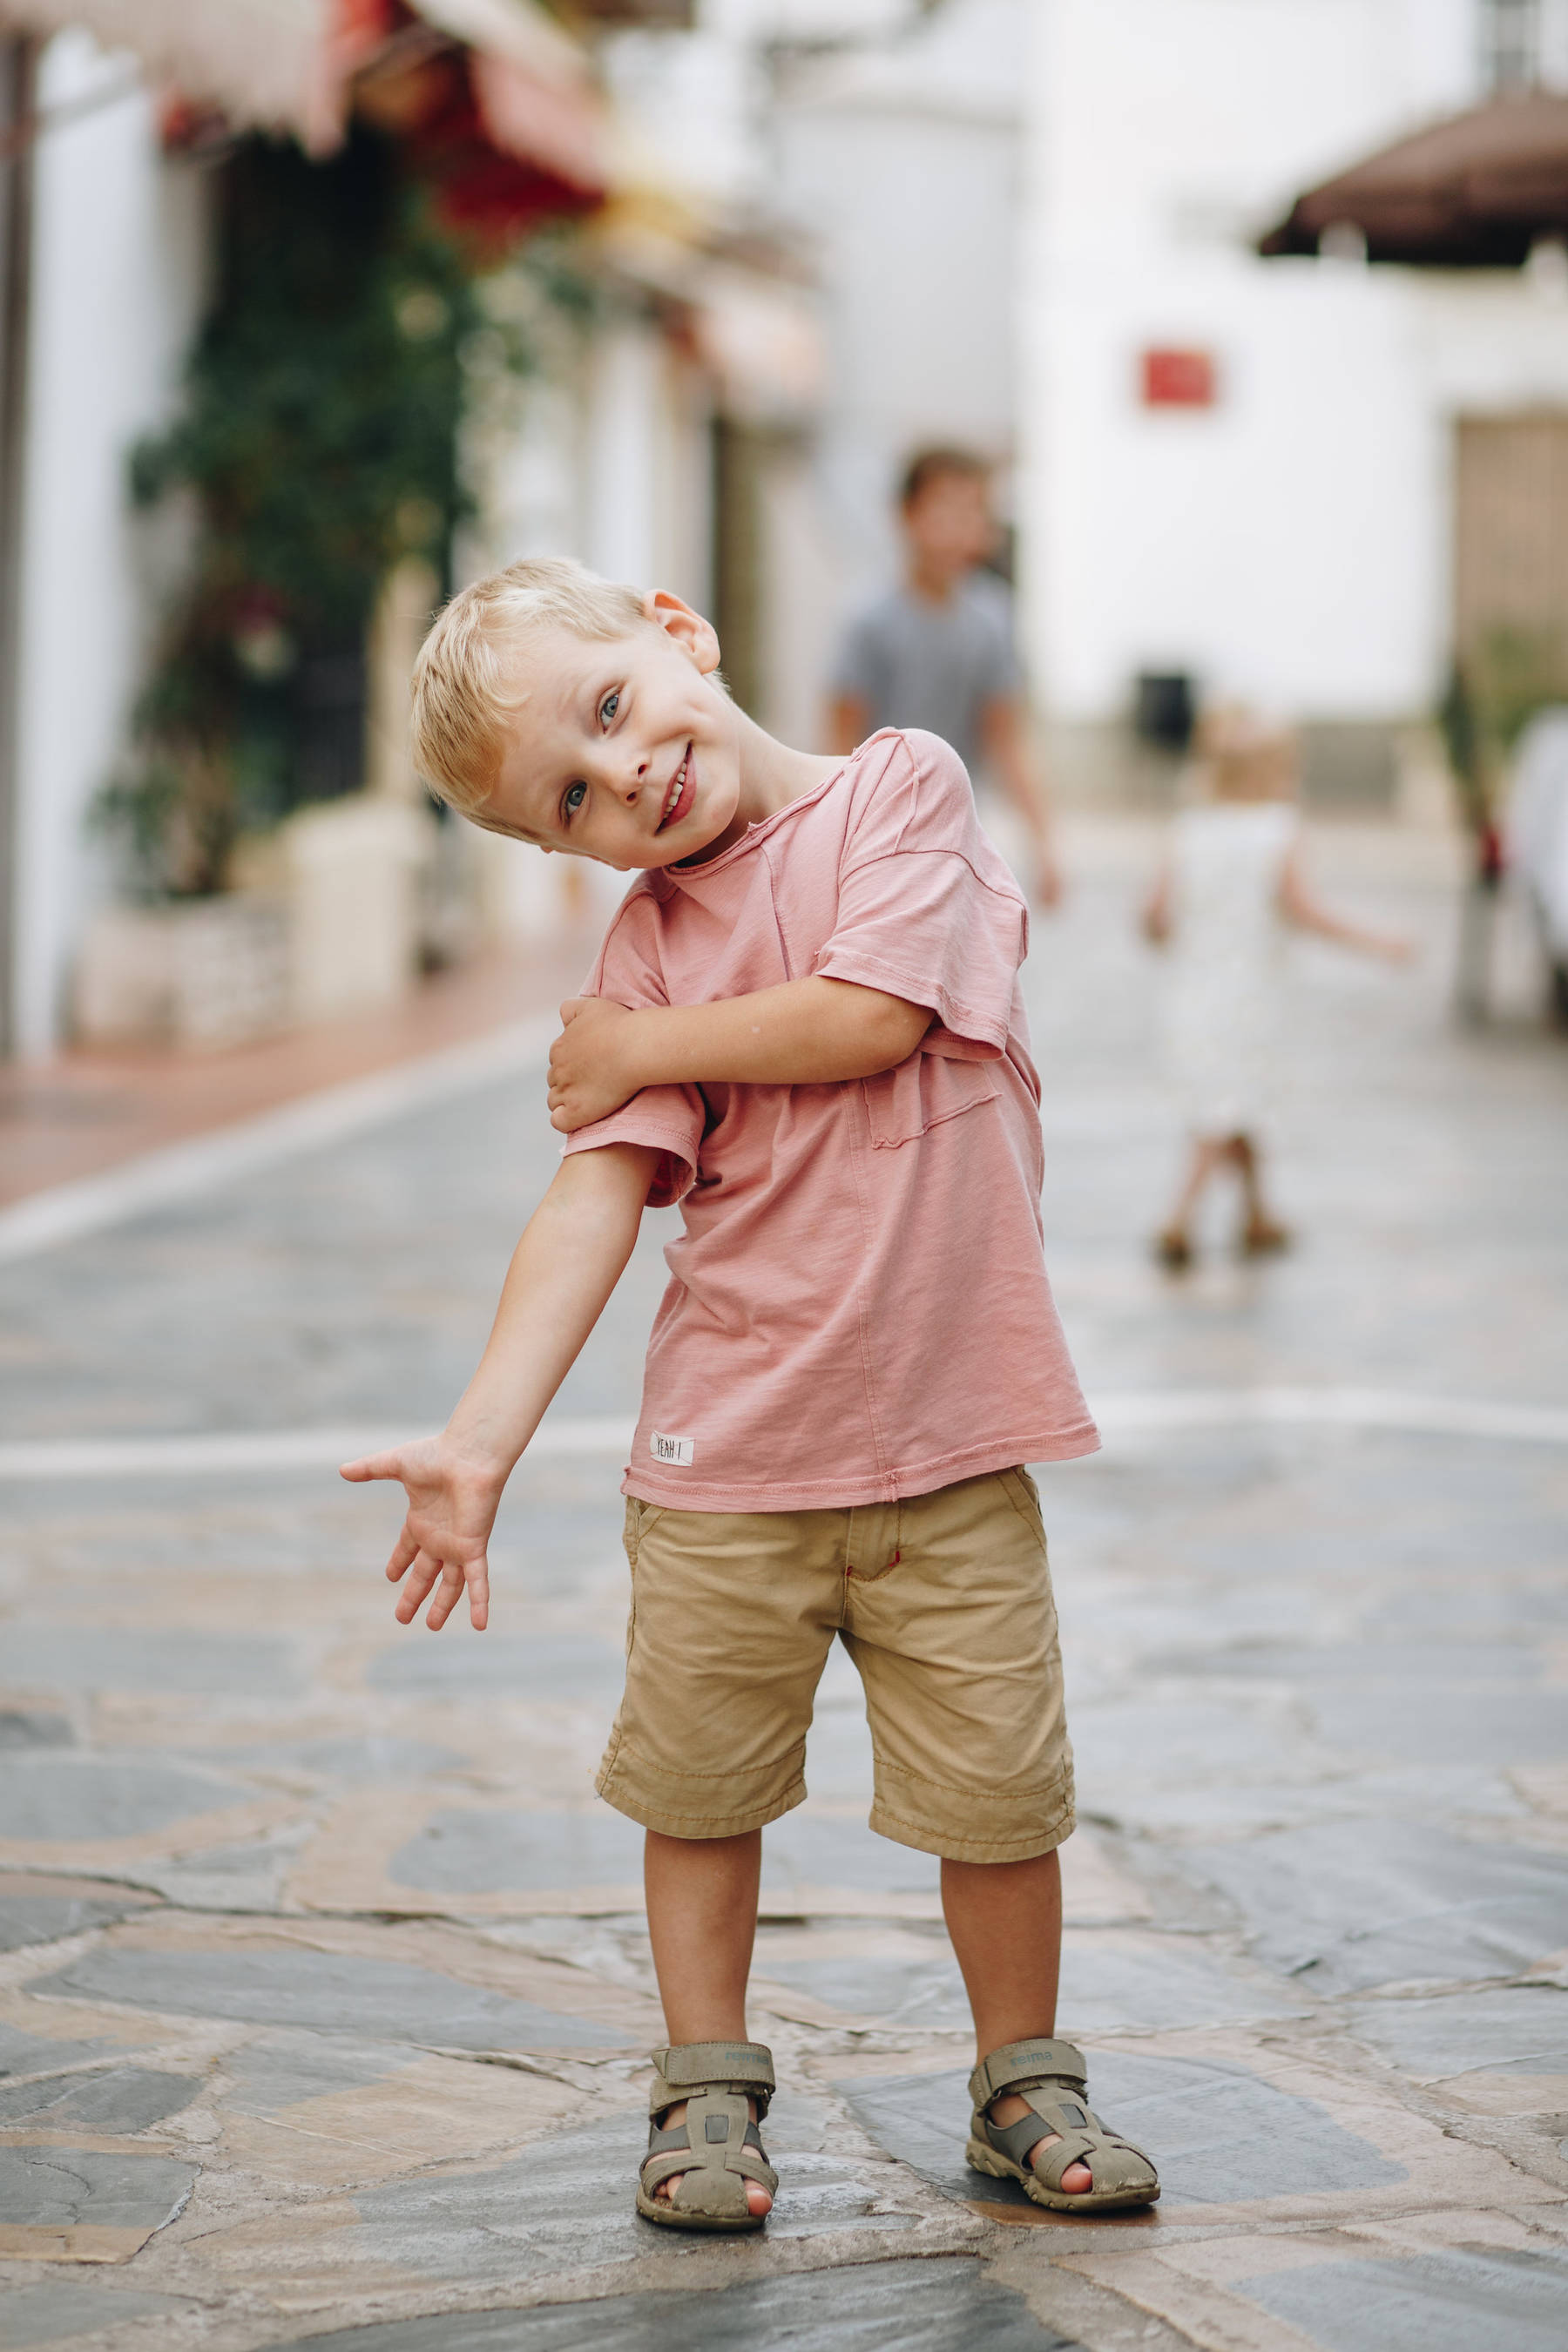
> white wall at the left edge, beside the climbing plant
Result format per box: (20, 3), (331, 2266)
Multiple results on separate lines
(17, 33), (206, 1056)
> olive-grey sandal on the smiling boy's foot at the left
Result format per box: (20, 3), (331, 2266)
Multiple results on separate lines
(637, 2042), (778, 2230)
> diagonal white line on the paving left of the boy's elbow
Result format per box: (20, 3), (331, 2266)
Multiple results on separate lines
(0, 1014), (559, 1263)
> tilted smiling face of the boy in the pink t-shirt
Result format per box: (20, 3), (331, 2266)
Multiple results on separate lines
(484, 592), (745, 873)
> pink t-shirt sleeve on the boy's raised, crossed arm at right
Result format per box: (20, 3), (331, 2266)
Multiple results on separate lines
(815, 732), (1030, 1061)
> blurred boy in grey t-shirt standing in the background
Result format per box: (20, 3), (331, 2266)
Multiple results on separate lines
(828, 447), (1063, 906)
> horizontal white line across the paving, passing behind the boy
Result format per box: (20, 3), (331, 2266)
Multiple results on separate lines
(0, 1388), (1568, 1482)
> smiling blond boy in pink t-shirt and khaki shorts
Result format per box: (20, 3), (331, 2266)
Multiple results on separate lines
(343, 560), (1159, 2230)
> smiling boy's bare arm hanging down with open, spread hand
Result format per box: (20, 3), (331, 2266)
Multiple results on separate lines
(343, 1143), (659, 1630)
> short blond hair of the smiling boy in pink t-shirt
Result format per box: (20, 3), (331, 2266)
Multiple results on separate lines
(414, 555), (646, 823)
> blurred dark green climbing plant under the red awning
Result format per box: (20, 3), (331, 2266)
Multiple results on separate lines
(94, 127), (573, 896)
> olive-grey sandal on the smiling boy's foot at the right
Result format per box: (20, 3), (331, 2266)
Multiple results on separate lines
(966, 2042), (1159, 2213)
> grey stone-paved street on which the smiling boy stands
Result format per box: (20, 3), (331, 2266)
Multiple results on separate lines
(0, 821), (1568, 2352)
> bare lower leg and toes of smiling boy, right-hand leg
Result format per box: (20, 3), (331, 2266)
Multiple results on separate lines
(943, 1854), (1093, 2197)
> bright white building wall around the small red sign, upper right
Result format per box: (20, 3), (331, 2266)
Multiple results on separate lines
(1020, 0), (1568, 720)
